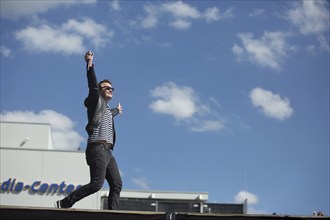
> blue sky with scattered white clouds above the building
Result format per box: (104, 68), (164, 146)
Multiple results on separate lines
(1, 0), (330, 215)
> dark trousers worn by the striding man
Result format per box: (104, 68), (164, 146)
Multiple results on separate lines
(61, 143), (122, 210)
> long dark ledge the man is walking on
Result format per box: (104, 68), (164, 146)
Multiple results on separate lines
(0, 206), (330, 220)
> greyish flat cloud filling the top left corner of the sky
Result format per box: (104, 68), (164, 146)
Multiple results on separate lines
(0, 0), (97, 20)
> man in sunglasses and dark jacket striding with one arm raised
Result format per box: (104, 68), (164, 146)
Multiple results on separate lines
(55, 51), (122, 210)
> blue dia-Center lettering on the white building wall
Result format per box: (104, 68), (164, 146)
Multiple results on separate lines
(0, 178), (81, 195)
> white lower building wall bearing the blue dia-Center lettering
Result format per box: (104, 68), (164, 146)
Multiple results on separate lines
(0, 148), (104, 209)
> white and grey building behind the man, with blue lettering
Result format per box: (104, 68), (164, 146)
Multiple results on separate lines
(0, 122), (246, 214)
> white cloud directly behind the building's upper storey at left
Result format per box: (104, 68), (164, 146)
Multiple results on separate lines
(0, 110), (84, 150)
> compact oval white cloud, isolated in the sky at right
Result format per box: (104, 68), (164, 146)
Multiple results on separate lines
(250, 87), (293, 120)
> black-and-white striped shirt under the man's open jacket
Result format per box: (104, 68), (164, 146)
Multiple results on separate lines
(88, 106), (113, 144)
